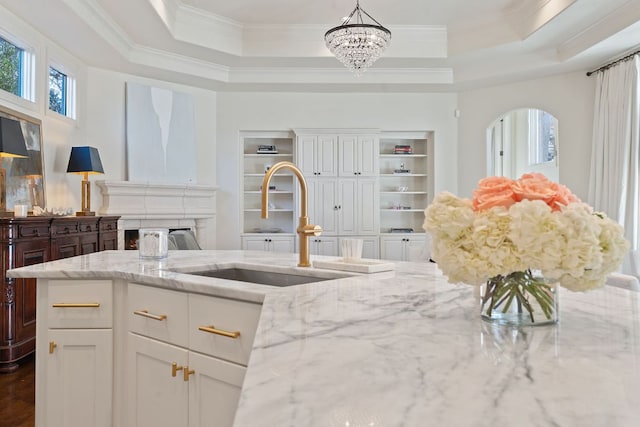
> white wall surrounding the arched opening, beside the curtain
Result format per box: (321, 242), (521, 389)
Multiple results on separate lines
(458, 72), (595, 201)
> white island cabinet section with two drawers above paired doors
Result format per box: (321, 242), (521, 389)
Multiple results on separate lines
(127, 283), (261, 427)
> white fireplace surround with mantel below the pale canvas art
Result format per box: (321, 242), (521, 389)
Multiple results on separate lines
(95, 180), (216, 249)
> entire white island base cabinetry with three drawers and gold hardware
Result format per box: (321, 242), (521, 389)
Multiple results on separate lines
(36, 280), (262, 427)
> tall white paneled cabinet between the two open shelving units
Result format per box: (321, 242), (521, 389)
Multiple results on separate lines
(296, 129), (379, 258)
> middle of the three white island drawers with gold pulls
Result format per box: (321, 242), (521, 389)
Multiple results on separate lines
(127, 283), (189, 347)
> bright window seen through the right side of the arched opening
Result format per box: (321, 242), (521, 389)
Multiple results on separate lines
(529, 109), (558, 165)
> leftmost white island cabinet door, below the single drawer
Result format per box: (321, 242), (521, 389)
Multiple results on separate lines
(46, 329), (113, 427)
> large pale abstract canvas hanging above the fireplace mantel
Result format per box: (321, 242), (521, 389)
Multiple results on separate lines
(126, 82), (197, 184)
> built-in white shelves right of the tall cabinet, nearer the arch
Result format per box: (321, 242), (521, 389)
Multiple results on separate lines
(379, 131), (433, 234)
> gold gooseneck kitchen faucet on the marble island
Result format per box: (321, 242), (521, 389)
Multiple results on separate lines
(262, 162), (322, 267)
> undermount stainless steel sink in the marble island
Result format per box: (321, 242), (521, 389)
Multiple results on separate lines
(180, 267), (351, 286)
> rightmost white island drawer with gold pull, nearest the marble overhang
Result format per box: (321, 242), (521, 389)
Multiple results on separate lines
(189, 294), (262, 366)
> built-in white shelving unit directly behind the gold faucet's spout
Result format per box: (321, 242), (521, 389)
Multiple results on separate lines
(241, 131), (296, 251)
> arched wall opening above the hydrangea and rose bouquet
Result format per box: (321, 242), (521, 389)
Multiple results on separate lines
(487, 108), (559, 181)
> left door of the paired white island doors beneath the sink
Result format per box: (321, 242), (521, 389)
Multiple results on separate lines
(128, 333), (190, 427)
